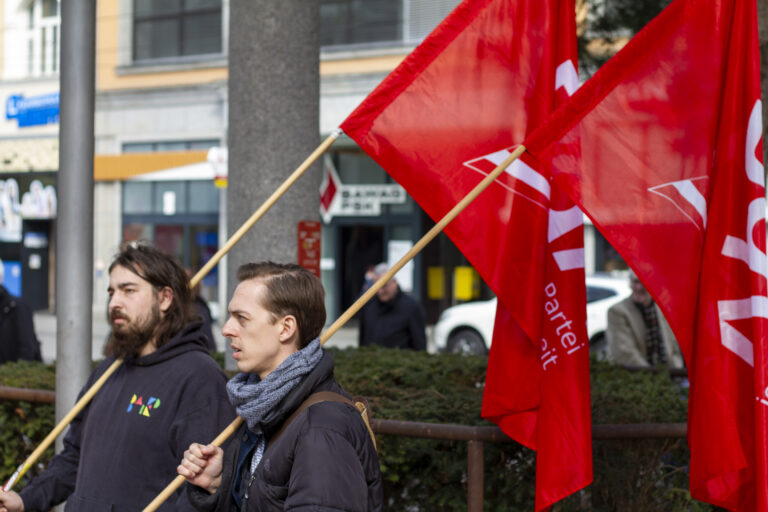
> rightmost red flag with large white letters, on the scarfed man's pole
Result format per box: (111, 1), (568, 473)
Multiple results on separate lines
(524, 0), (768, 511)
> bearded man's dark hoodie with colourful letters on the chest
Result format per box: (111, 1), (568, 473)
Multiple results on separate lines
(20, 322), (235, 512)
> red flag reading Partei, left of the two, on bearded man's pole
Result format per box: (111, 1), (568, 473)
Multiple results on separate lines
(341, 0), (592, 510)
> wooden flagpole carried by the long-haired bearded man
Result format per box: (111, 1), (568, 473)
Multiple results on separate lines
(2, 133), (341, 496)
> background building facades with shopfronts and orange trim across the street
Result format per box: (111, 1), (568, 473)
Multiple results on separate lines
(0, 0), (623, 328)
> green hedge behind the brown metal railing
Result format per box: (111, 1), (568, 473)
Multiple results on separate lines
(0, 347), (716, 512)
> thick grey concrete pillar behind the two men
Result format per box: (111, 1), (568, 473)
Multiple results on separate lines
(228, 0), (321, 363)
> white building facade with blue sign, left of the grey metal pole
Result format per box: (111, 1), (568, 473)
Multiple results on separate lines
(0, 0), (59, 309)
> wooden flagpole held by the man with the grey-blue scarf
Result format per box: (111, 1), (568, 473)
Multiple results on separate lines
(142, 144), (525, 512)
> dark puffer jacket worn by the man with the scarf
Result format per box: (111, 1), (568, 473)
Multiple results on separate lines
(190, 350), (382, 512)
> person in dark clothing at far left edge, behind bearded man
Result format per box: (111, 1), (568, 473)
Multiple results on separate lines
(0, 260), (42, 364)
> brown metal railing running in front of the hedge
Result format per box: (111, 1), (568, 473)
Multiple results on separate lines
(0, 386), (686, 512)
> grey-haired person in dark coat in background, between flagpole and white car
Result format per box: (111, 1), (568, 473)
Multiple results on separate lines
(357, 263), (427, 350)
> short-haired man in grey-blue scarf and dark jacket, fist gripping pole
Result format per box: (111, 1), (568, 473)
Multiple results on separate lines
(178, 262), (382, 512)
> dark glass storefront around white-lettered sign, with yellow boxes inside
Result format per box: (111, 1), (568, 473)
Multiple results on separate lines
(323, 149), (493, 323)
